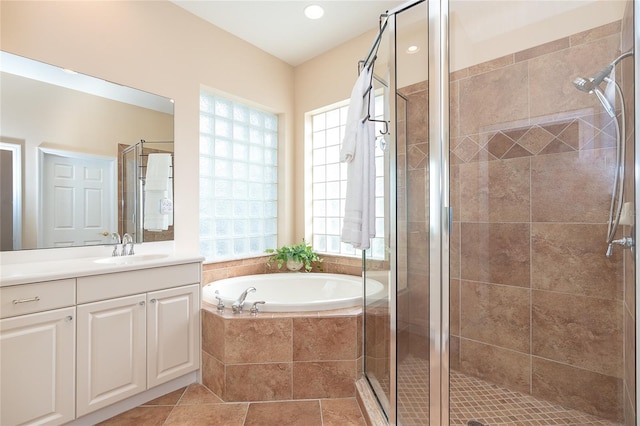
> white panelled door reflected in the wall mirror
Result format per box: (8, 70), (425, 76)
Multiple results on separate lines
(39, 152), (117, 247)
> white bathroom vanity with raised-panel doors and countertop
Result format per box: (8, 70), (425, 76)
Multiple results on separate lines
(0, 251), (202, 425)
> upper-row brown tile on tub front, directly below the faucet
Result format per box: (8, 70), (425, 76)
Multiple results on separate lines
(223, 318), (292, 364)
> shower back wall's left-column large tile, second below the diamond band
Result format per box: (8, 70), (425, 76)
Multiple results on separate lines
(460, 223), (530, 287)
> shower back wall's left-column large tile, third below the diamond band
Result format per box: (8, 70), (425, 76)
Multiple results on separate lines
(460, 281), (531, 353)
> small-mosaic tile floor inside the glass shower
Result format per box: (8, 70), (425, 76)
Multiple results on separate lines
(398, 356), (619, 426)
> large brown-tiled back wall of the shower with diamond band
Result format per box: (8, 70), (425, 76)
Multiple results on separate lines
(444, 22), (633, 421)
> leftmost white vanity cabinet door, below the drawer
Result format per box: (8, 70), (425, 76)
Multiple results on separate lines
(0, 308), (75, 426)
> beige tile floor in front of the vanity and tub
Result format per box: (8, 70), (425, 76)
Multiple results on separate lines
(100, 384), (365, 426)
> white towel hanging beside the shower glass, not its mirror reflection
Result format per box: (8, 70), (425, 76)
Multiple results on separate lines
(340, 67), (376, 250)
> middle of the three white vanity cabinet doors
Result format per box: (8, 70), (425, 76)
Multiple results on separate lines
(77, 294), (146, 417)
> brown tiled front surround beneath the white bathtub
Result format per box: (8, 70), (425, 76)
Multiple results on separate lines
(202, 303), (362, 402)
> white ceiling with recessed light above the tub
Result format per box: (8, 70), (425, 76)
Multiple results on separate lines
(172, 0), (406, 66)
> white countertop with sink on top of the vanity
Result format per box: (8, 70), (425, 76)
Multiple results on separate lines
(0, 244), (203, 287)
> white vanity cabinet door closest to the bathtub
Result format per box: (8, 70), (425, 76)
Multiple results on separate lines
(147, 284), (200, 388)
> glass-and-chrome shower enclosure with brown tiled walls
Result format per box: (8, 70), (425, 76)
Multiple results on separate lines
(363, 0), (639, 426)
